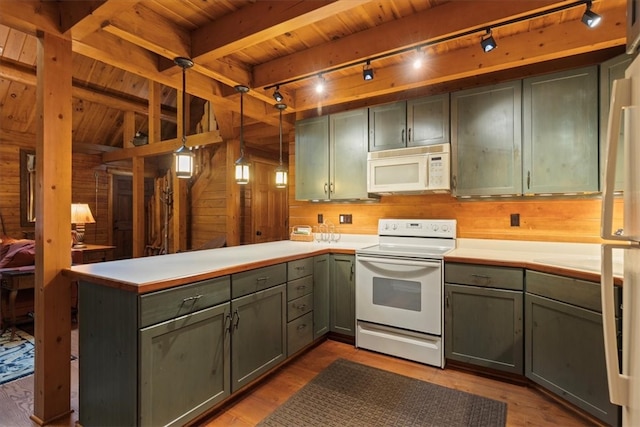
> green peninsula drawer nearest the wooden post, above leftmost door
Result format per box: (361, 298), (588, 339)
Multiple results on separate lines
(138, 276), (230, 328)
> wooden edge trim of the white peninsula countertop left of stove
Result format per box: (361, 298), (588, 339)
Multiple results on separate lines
(62, 248), (355, 295)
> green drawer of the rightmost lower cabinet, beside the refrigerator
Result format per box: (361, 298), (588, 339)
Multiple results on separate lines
(527, 270), (621, 317)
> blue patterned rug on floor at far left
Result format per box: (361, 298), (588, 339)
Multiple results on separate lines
(0, 329), (35, 384)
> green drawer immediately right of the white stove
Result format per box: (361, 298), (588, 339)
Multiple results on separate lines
(444, 262), (524, 291)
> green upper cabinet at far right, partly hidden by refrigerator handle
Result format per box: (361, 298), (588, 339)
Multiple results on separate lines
(600, 54), (632, 191)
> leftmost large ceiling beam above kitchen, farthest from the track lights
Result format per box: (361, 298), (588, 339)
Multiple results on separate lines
(192, 0), (371, 60)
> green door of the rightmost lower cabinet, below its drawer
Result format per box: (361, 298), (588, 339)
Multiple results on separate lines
(525, 293), (620, 425)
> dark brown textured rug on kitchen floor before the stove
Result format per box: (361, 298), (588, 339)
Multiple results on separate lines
(258, 359), (507, 427)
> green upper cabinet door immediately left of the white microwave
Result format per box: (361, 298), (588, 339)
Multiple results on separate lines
(329, 109), (368, 199)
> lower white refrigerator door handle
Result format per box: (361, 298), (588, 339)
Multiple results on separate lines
(600, 244), (633, 406)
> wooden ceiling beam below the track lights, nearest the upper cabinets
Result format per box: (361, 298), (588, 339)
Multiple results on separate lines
(296, 8), (626, 110)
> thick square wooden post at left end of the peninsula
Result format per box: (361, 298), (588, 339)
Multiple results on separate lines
(31, 33), (72, 425)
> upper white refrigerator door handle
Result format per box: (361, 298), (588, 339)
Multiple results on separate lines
(600, 79), (631, 240)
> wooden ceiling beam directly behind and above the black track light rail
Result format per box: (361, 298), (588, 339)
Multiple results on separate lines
(253, 0), (569, 88)
